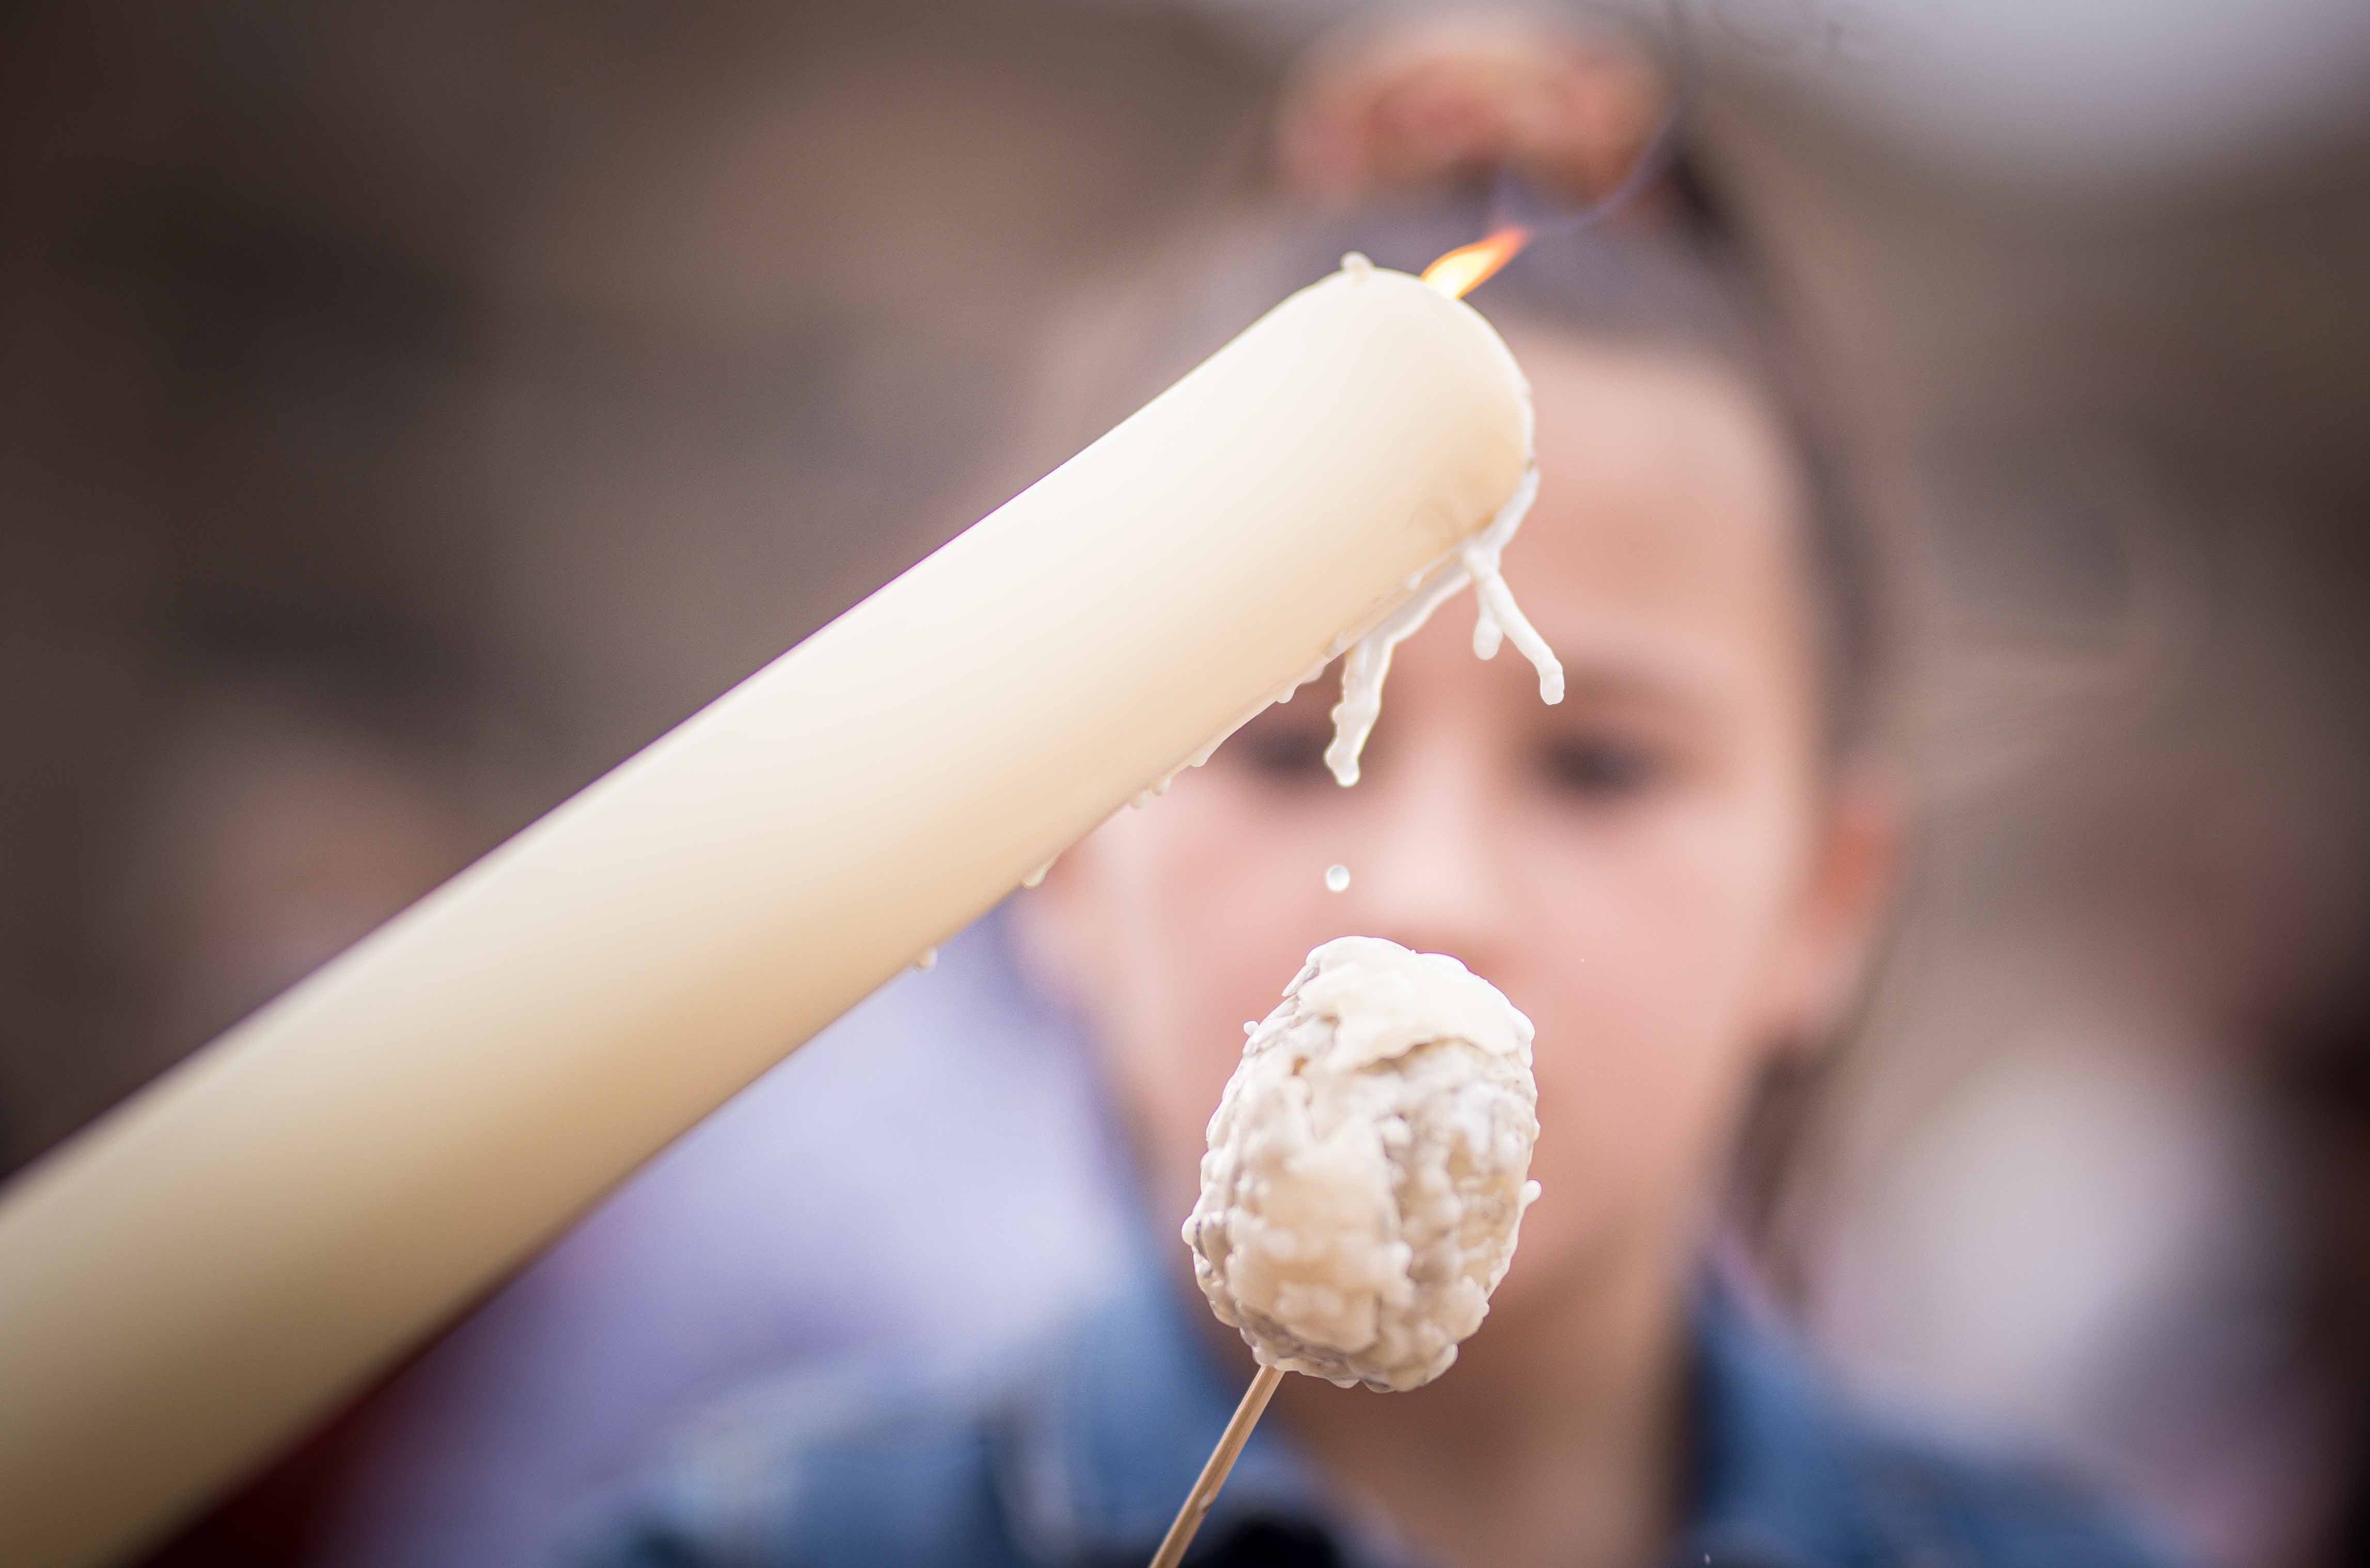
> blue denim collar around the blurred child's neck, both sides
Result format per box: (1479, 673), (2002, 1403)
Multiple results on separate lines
(995, 1258), (1884, 1568)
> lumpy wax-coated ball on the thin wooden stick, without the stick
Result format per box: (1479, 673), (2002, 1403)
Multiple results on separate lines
(1185, 936), (1538, 1390)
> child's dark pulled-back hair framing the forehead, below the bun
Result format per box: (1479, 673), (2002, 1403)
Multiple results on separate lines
(1038, 170), (1887, 755)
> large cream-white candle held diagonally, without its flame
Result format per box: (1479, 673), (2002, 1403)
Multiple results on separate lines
(0, 265), (1531, 1565)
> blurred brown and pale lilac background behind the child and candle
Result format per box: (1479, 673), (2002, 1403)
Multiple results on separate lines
(0, 0), (2370, 1565)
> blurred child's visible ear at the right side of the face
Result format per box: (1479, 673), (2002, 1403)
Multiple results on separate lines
(1775, 761), (1908, 1049)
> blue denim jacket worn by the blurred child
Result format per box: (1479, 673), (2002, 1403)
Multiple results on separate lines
(571, 1265), (2166, 1568)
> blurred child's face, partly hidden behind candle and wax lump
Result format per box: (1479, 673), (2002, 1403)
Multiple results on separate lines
(1019, 336), (1889, 1314)
